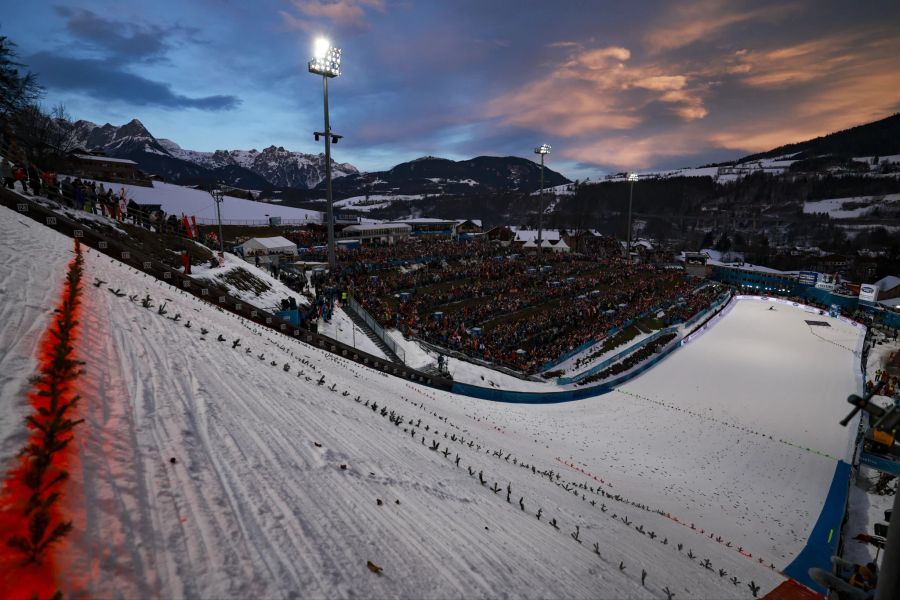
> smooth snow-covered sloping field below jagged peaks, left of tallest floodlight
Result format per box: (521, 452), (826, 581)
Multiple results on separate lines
(70, 179), (322, 224)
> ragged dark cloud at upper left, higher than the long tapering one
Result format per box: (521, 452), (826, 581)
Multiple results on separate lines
(54, 6), (197, 62)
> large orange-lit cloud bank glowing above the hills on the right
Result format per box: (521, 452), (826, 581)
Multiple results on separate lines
(488, 23), (900, 169)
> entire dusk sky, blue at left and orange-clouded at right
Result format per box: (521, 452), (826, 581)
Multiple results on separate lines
(7, 0), (900, 178)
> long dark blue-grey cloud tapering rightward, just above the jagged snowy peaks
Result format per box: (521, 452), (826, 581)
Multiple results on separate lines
(28, 52), (241, 111)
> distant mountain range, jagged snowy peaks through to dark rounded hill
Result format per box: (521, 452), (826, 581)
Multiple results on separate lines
(70, 119), (569, 199)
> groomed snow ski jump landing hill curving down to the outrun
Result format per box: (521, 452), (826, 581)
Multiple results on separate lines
(0, 203), (861, 598)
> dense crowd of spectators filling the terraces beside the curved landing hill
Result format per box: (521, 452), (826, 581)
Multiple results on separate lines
(312, 241), (718, 373)
